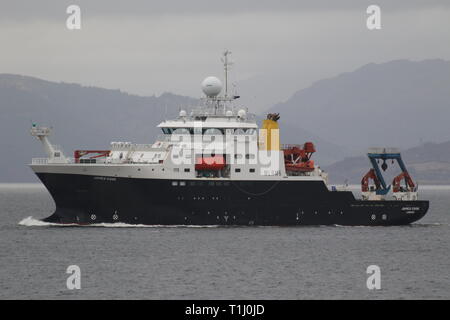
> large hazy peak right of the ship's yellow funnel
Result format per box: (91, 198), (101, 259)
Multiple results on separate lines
(271, 60), (450, 154)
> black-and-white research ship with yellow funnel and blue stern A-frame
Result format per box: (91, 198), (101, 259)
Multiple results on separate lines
(30, 51), (429, 226)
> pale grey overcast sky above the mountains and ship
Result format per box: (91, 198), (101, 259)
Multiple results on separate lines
(0, 0), (450, 111)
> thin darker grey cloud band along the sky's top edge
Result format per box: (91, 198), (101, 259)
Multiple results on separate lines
(0, 0), (450, 22)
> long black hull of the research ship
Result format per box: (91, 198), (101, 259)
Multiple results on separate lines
(37, 173), (429, 226)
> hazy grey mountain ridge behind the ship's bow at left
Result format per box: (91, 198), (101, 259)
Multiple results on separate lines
(0, 74), (198, 182)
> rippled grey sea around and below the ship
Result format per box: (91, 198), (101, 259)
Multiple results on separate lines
(0, 184), (450, 299)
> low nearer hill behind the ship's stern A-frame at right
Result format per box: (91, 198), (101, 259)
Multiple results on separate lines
(324, 141), (450, 184)
